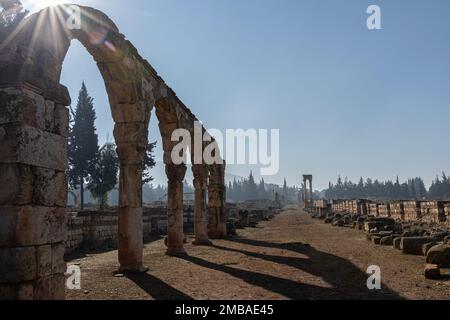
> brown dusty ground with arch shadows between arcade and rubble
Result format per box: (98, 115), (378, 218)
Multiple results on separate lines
(67, 209), (450, 299)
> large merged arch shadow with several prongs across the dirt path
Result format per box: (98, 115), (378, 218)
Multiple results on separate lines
(207, 237), (403, 299)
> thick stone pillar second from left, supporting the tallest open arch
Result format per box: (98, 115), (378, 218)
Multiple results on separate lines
(114, 129), (148, 272)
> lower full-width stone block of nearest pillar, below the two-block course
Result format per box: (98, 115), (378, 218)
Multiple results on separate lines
(0, 206), (66, 247)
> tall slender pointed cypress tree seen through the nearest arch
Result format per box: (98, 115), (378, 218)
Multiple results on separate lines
(67, 82), (99, 210)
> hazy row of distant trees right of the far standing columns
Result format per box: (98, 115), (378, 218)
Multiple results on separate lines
(325, 173), (450, 200)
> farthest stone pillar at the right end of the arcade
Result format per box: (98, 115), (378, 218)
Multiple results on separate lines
(208, 165), (227, 239)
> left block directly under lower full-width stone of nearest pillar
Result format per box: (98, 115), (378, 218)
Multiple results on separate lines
(0, 247), (37, 284)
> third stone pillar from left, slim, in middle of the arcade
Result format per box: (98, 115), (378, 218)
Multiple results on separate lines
(166, 163), (186, 256)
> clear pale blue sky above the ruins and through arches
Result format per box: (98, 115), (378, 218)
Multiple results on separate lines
(24, 0), (450, 188)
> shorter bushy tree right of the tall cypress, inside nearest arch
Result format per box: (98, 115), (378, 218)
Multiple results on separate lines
(87, 143), (119, 210)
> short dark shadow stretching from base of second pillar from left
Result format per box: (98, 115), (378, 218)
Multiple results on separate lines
(126, 273), (193, 300)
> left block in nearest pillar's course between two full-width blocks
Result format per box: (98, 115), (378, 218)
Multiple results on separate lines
(0, 164), (33, 205)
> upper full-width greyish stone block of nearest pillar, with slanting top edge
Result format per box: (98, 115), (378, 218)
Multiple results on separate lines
(0, 125), (67, 171)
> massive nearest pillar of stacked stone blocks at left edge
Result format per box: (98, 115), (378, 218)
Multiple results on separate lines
(0, 84), (70, 300)
